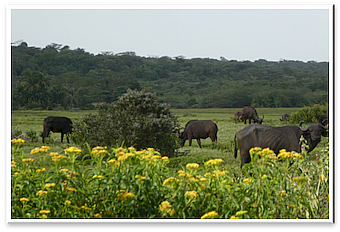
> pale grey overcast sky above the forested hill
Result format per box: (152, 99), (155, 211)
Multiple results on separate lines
(10, 5), (329, 61)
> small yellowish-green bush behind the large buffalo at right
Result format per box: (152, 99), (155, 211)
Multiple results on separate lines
(287, 103), (328, 123)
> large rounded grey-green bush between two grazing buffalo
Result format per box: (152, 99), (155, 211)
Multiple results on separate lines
(73, 90), (178, 156)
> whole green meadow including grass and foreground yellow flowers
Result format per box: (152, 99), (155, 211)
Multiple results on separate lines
(11, 108), (328, 219)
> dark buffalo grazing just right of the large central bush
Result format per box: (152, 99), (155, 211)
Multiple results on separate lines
(179, 120), (218, 148)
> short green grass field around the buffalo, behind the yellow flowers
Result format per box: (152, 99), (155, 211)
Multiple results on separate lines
(11, 108), (326, 176)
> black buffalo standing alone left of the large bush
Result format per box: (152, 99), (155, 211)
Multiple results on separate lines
(42, 116), (72, 143)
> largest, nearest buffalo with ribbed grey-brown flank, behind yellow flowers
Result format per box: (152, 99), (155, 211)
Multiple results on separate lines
(234, 121), (328, 168)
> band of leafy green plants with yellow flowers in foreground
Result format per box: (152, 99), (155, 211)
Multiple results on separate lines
(11, 139), (329, 219)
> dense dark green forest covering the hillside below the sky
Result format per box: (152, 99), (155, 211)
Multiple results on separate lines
(11, 42), (328, 109)
